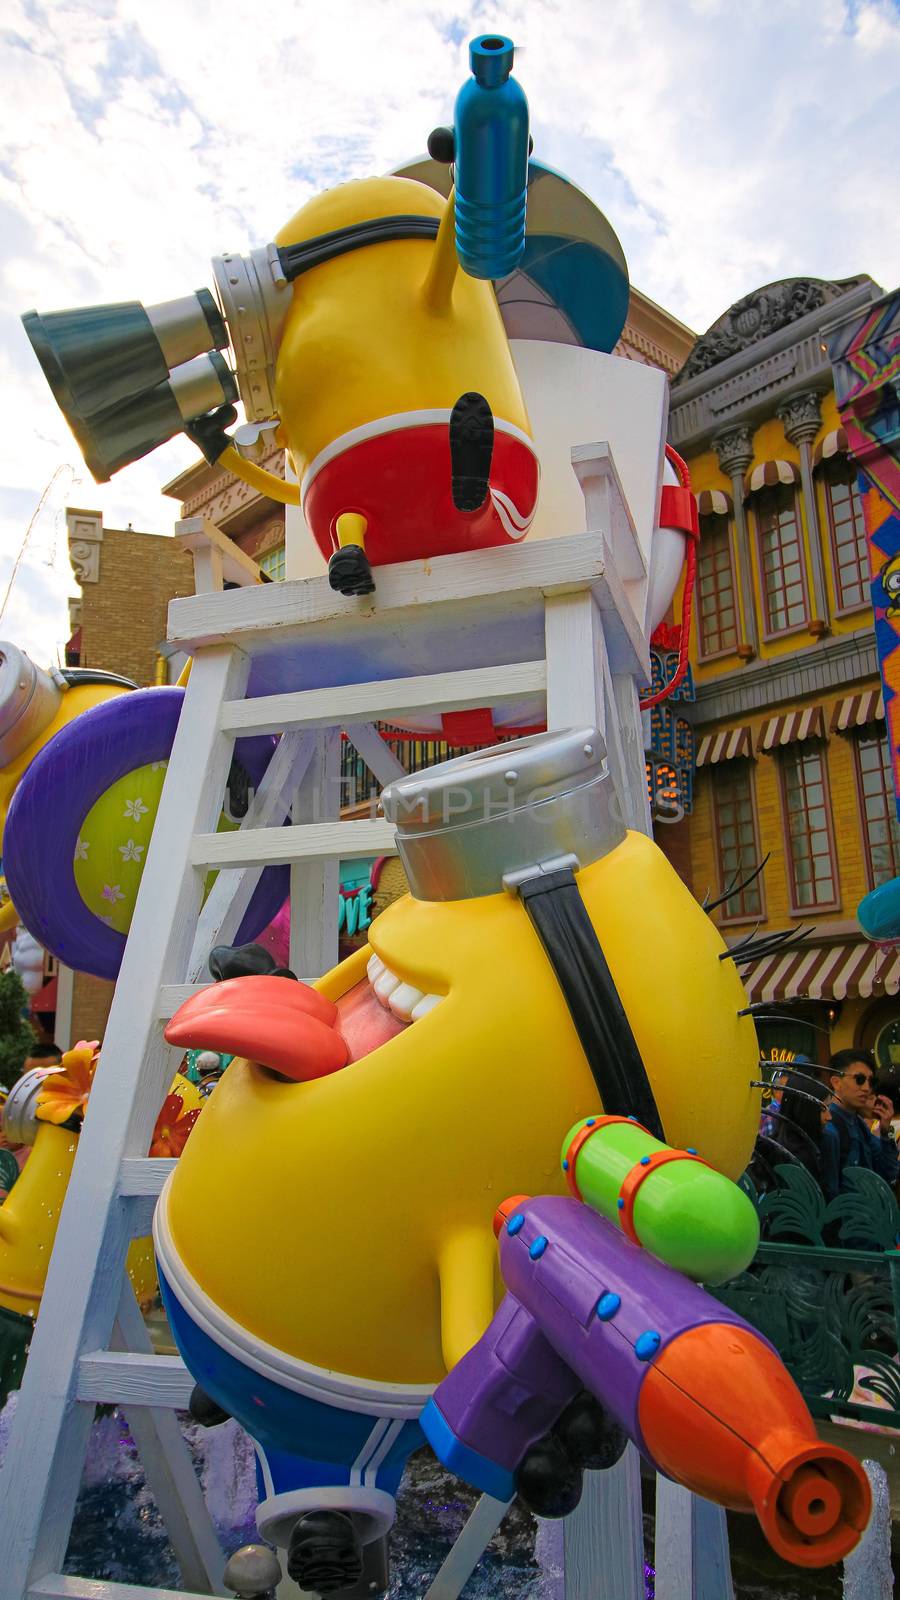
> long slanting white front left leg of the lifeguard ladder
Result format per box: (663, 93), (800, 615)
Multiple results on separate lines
(0, 648), (250, 1597)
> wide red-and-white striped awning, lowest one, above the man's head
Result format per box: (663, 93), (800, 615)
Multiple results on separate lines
(743, 939), (900, 1003)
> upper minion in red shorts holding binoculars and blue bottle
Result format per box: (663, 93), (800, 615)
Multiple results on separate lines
(22, 35), (544, 595)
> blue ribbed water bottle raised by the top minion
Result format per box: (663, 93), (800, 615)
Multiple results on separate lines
(455, 34), (528, 278)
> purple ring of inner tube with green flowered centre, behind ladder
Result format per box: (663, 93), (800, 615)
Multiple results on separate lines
(3, 688), (290, 979)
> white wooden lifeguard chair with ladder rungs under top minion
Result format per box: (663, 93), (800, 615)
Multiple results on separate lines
(0, 446), (720, 1600)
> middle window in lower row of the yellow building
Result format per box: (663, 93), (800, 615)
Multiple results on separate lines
(778, 741), (838, 910)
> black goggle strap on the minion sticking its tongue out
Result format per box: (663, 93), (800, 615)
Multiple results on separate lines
(517, 867), (665, 1139)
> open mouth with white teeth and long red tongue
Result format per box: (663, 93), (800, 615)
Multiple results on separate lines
(165, 952), (444, 1083)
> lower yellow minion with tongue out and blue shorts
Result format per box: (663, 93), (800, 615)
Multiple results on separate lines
(155, 730), (757, 1594)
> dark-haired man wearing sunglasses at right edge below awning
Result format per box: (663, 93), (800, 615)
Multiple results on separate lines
(822, 1050), (900, 1222)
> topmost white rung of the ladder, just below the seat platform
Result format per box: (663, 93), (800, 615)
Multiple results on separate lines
(221, 661), (546, 734)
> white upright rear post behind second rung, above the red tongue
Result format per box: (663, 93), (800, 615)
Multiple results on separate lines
(291, 728), (339, 982)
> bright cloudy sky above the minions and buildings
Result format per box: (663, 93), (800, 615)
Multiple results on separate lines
(0, 0), (900, 664)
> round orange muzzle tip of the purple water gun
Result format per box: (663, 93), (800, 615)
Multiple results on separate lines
(753, 1440), (871, 1566)
